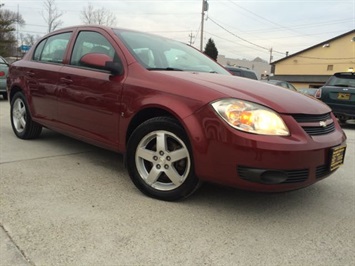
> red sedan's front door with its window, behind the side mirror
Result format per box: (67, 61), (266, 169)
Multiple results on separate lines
(58, 31), (122, 148)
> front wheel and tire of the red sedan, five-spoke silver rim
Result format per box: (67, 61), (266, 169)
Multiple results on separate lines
(127, 117), (199, 201)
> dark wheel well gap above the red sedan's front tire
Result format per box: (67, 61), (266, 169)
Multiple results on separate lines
(126, 108), (180, 143)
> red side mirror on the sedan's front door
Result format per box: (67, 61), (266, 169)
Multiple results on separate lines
(80, 53), (123, 75)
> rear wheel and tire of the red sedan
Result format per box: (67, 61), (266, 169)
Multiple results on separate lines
(10, 92), (42, 139)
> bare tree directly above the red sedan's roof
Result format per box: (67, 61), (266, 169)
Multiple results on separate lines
(81, 3), (116, 26)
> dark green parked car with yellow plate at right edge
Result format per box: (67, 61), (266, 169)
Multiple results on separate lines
(316, 72), (355, 123)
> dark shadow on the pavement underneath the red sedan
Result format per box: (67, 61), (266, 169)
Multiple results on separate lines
(35, 129), (326, 212)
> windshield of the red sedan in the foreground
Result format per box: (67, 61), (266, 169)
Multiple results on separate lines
(114, 30), (231, 75)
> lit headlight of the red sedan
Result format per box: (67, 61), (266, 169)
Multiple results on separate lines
(211, 99), (290, 136)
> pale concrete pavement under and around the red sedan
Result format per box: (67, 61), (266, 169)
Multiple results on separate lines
(0, 99), (355, 266)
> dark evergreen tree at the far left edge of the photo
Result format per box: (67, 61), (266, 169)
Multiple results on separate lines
(0, 4), (25, 56)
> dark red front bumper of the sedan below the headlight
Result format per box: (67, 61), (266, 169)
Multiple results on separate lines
(186, 109), (346, 192)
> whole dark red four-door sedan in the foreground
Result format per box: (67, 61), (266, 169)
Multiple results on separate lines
(8, 26), (346, 200)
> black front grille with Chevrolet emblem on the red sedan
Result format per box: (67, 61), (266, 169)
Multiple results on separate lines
(293, 113), (335, 136)
